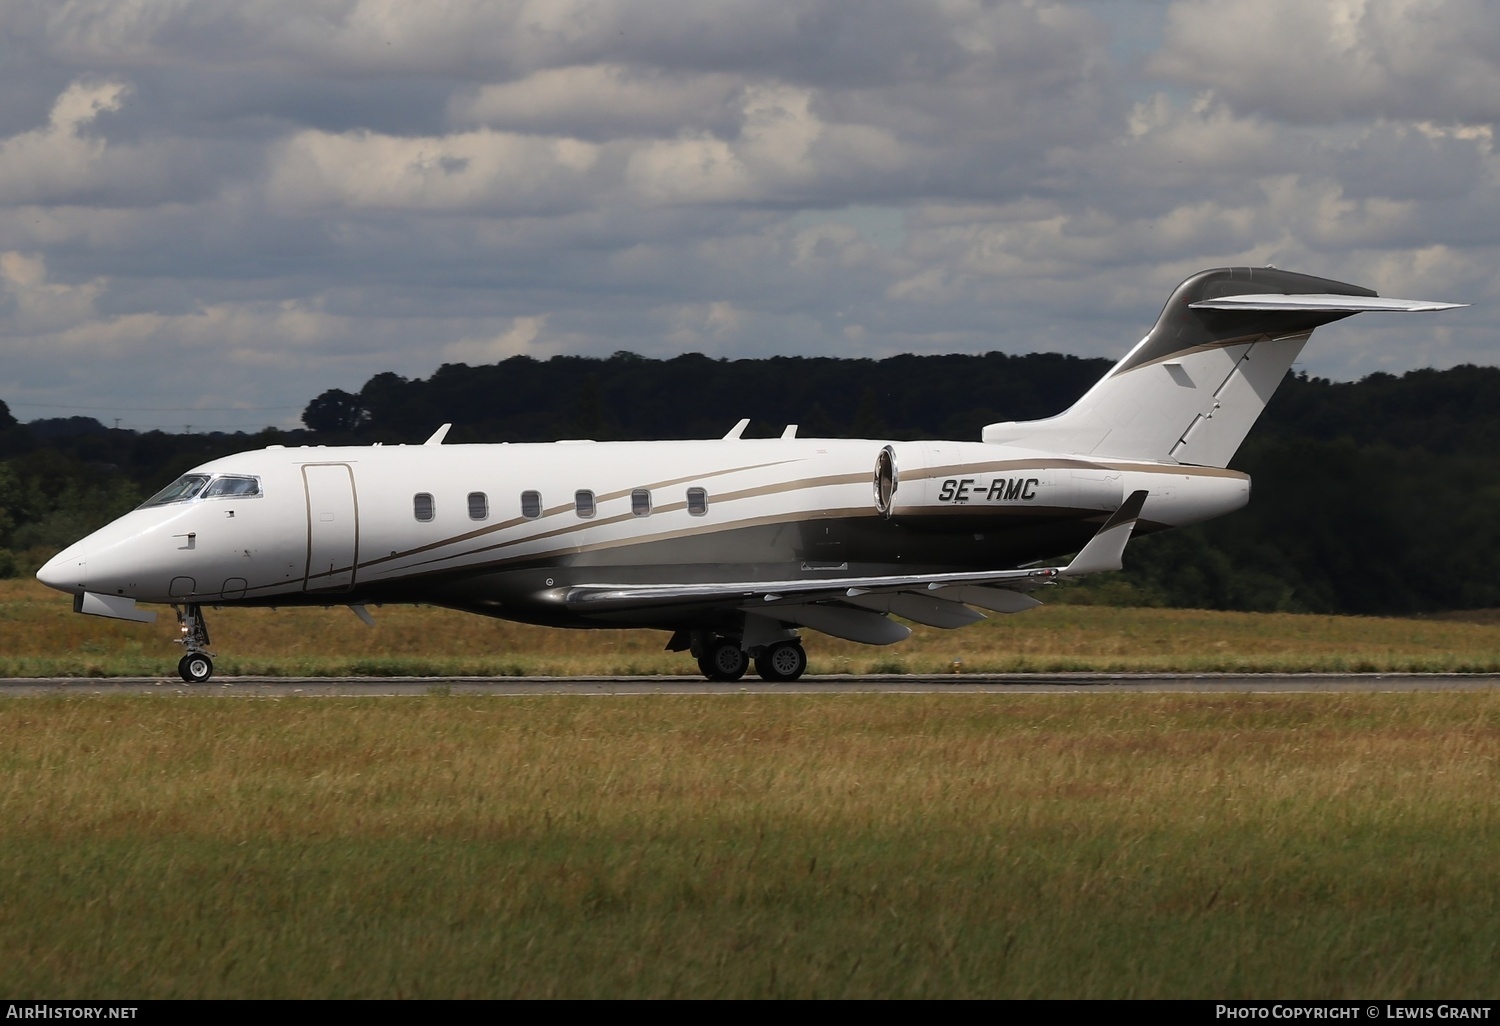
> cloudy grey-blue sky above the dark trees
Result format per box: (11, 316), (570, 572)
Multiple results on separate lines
(0, 0), (1500, 431)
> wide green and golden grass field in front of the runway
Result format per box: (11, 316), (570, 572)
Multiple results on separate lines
(0, 692), (1500, 999)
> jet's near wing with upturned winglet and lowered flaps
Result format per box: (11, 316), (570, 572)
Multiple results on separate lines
(566, 491), (1146, 645)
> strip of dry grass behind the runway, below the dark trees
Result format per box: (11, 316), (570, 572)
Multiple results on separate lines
(0, 581), (1500, 677)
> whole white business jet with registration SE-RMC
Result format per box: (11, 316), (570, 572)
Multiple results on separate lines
(36, 267), (1461, 683)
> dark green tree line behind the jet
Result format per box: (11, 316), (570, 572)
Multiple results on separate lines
(0, 353), (1500, 614)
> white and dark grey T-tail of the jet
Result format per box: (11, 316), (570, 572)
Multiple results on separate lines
(984, 267), (1466, 467)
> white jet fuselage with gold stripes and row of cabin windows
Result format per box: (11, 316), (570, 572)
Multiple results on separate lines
(41, 438), (1250, 630)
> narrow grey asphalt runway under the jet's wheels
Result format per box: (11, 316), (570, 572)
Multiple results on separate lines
(0, 674), (1500, 698)
